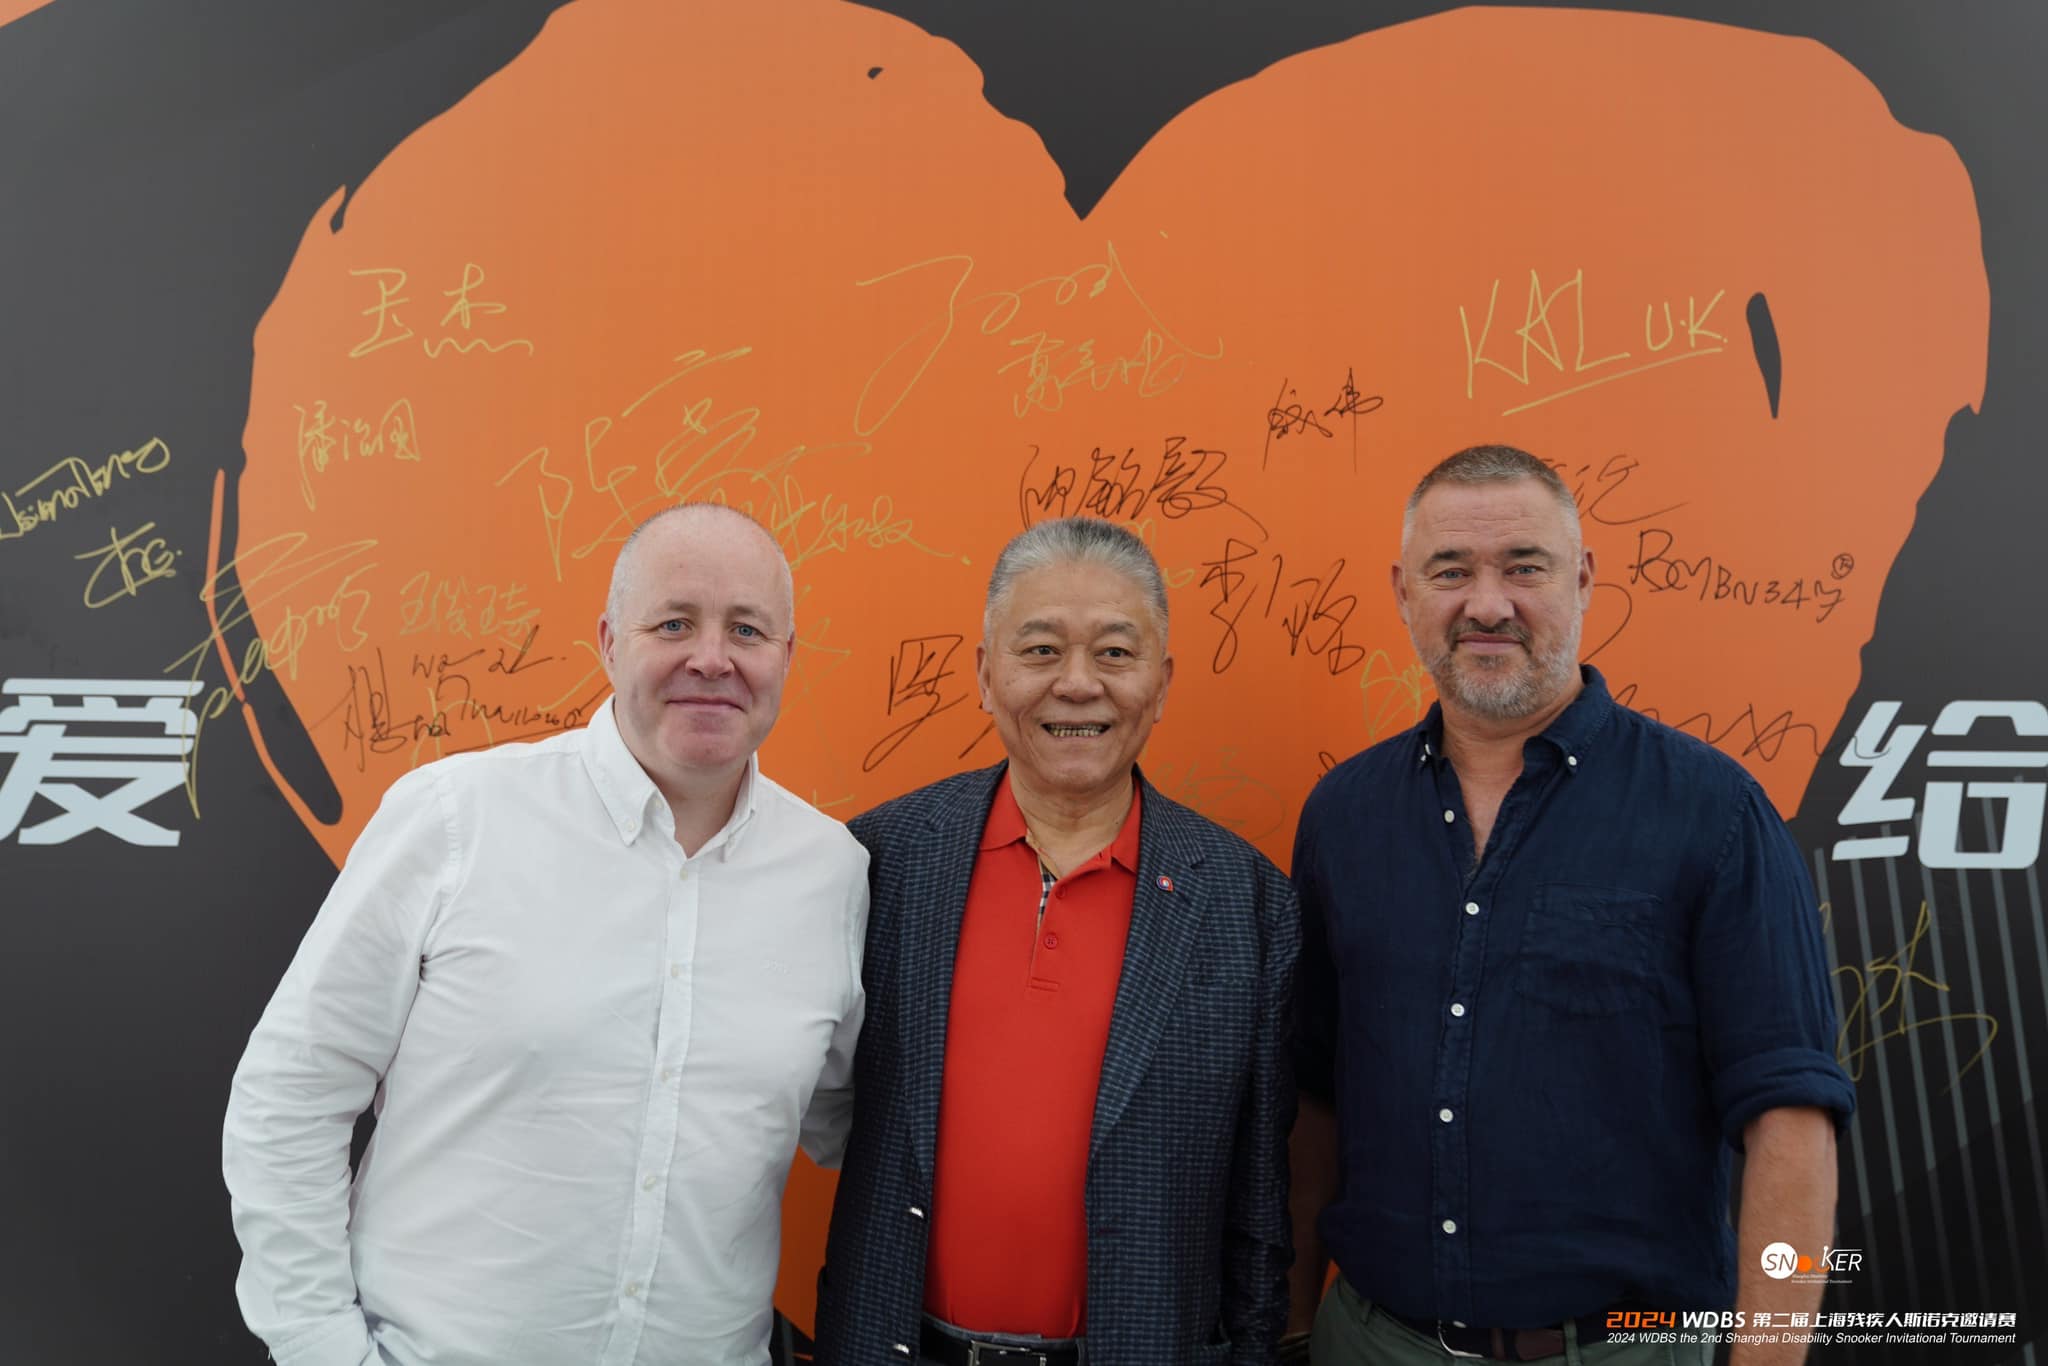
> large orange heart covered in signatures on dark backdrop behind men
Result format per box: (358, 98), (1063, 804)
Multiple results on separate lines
(213, 0), (1989, 1323)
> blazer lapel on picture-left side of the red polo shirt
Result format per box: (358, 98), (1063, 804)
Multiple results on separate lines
(897, 764), (1004, 1180)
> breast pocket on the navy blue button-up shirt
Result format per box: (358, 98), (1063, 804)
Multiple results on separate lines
(1516, 883), (1663, 1016)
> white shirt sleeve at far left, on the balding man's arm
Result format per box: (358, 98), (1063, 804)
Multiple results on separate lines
(221, 770), (457, 1366)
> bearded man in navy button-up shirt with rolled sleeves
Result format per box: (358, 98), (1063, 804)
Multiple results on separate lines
(1290, 446), (1855, 1366)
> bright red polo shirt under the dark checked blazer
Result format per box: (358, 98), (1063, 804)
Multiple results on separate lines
(924, 774), (1139, 1337)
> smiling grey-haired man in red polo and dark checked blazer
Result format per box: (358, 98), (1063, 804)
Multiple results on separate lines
(817, 518), (1298, 1366)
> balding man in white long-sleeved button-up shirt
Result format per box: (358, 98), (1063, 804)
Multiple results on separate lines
(223, 506), (868, 1366)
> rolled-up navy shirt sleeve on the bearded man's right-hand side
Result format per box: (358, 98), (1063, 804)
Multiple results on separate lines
(1692, 782), (1855, 1149)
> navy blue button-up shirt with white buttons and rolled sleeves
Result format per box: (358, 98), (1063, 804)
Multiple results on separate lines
(1294, 668), (1855, 1327)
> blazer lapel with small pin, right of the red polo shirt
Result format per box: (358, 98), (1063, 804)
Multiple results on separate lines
(1087, 774), (1206, 1161)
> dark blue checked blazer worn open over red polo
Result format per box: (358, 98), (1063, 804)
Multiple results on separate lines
(817, 764), (1300, 1366)
